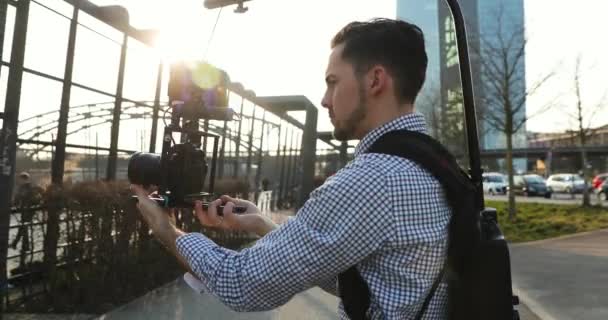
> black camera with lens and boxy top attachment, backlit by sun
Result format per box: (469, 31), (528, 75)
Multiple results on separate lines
(127, 63), (244, 212)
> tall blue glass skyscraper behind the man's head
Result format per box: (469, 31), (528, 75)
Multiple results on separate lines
(397, 0), (526, 155)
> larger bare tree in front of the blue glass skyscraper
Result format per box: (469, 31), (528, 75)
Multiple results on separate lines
(473, 9), (554, 219)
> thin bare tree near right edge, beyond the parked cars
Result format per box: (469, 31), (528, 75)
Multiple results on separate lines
(569, 55), (604, 207)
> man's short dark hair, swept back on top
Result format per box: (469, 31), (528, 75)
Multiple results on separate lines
(331, 19), (427, 103)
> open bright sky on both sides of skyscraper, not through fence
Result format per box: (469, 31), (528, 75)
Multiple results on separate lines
(101, 0), (608, 131)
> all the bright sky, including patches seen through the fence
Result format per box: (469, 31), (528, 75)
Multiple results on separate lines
(7, 0), (608, 154)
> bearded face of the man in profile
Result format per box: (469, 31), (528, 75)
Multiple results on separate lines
(321, 44), (366, 141)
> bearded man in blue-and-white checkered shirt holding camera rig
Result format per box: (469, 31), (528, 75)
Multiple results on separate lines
(133, 19), (451, 319)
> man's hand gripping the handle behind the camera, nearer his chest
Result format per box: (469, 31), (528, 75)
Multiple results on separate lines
(194, 195), (278, 236)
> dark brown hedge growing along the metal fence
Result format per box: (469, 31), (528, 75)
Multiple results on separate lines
(11, 181), (252, 313)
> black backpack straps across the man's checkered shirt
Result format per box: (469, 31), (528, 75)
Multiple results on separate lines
(338, 130), (472, 320)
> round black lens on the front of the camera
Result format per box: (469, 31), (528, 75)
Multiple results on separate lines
(127, 152), (161, 186)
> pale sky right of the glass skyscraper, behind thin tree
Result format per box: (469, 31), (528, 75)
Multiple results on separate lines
(524, 0), (608, 131)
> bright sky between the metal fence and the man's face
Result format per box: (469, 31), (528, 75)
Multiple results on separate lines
(95, 0), (396, 131)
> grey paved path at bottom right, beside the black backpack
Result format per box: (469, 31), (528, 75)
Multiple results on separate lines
(511, 229), (608, 320)
